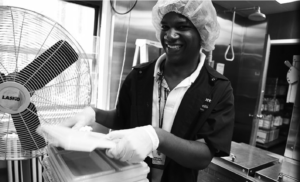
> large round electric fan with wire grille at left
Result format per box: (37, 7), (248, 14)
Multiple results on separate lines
(0, 6), (91, 160)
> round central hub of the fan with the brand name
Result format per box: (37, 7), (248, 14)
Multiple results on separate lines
(0, 81), (30, 114)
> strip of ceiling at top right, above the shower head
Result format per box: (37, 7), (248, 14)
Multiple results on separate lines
(212, 0), (300, 16)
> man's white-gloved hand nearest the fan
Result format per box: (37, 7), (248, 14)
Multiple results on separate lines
(59, 107), (95, 130)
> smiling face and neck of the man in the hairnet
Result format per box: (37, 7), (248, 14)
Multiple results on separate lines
(160, 12), (204, 90)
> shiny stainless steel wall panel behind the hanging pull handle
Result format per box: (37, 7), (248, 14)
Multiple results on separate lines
(212, 3), (267, 143)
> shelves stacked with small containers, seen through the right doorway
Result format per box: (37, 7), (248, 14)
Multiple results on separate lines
(256, 77), (292, 149)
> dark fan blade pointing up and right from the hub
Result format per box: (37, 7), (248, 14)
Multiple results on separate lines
(16, 40), (78, 92)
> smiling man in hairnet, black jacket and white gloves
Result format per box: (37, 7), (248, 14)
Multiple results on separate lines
(39, 0), (234, 182)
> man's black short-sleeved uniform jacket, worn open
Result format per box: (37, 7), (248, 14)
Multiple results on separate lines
(112, 61), (234, 182)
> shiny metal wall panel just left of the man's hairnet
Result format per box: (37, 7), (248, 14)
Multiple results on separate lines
(110, 0), (159, 108)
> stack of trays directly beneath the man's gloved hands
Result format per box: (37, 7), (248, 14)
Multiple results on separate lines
(43, 146), (149, 182)
